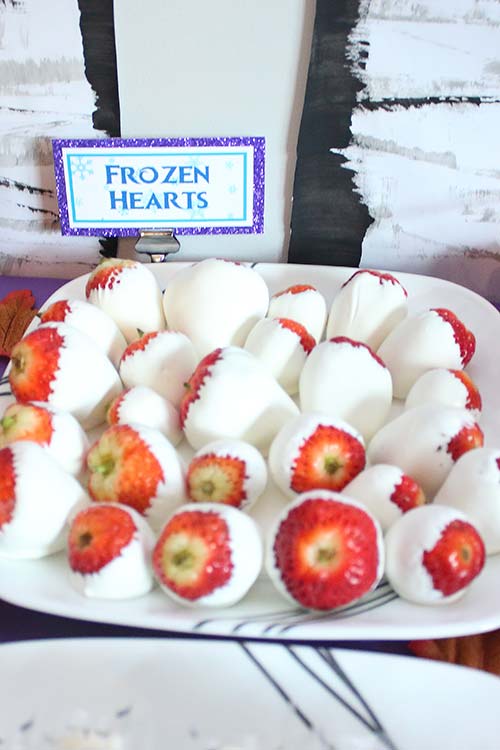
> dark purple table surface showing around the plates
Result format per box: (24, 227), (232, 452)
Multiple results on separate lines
(0, 276), (411, 655)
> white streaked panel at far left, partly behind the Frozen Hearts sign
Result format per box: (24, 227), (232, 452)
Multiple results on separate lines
(0, 0), (102, 277)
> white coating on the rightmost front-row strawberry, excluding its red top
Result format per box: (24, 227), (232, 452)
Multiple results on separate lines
(385, 504), (478, 604)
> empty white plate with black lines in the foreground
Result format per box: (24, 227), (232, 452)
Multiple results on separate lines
(0, 639), (500, 750)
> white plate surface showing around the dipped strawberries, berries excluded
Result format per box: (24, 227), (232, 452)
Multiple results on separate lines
(0, 263), (500, 640)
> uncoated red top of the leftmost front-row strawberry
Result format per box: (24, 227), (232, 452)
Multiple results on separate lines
(68, 505), (137, 574)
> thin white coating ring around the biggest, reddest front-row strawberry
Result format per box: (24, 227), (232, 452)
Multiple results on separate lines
(265, 490), (385, 605)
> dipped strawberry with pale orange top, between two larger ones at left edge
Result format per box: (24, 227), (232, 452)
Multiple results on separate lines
(0, 402), (89, 476)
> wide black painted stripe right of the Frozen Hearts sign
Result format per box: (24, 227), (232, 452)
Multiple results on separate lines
(288, 0), (372, 266)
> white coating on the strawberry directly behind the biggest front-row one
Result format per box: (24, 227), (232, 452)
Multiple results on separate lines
(269, 412), (364, 498)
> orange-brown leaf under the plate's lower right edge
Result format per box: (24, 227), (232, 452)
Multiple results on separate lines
(408, 630), (500, 676)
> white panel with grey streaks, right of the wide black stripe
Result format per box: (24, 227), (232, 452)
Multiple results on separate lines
(342, 0), (500, 301)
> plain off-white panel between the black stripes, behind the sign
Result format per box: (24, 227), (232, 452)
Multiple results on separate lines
(114, 0), (315, 261)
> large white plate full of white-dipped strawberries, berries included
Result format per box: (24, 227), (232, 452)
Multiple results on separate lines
(0, 258), (500, 640)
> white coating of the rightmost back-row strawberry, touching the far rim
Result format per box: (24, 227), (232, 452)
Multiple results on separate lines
(326, 270), (408, 352)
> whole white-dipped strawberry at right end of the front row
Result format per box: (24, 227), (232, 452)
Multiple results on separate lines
(385, 504), (485, 604)
